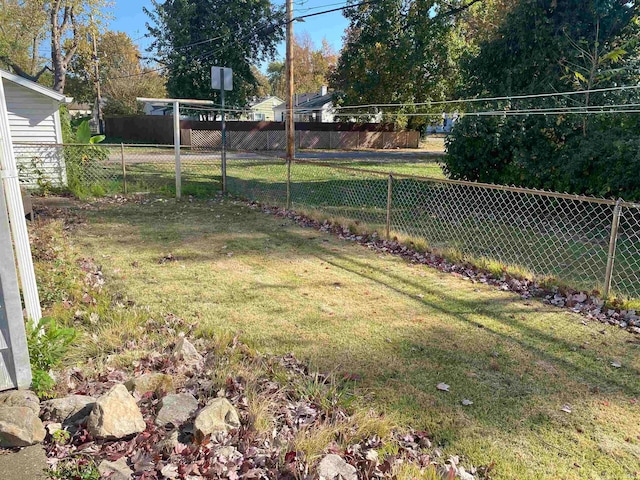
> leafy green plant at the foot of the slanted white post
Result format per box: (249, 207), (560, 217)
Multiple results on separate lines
(27, 318), (76, 397)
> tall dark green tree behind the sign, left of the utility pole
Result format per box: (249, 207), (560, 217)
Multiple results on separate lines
(145, 0), (284, 106)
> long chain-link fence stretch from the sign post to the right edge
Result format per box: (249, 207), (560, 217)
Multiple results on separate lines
(228, 159), (640, 298)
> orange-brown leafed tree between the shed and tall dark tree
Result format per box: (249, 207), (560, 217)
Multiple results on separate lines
(65, 30), (166, 115)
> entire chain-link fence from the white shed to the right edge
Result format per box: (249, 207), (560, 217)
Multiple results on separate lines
(15, 142), (640, 298)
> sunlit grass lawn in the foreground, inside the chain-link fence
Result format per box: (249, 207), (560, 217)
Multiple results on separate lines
(50, 195), (640, 479)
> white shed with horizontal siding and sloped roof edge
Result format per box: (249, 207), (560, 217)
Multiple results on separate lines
(0, 69), (71, 187)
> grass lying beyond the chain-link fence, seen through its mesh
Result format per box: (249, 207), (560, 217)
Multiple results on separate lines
(43, 147), (640, 298)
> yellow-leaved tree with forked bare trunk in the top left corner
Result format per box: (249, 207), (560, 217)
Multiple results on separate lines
(0, 0), (110, 93)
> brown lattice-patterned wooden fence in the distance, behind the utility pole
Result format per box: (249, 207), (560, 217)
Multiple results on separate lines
(181, 129), (420, 150)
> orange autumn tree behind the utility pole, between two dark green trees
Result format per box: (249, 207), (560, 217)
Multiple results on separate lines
(267, 33), (338, 98)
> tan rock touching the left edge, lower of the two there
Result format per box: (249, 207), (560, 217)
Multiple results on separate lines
(0, 406), (46, 447)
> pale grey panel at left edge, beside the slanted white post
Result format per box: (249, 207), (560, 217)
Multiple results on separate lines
(0, 185), (31, 391)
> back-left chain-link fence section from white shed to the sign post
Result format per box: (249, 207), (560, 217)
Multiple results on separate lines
(14, 143), (221, 197)
